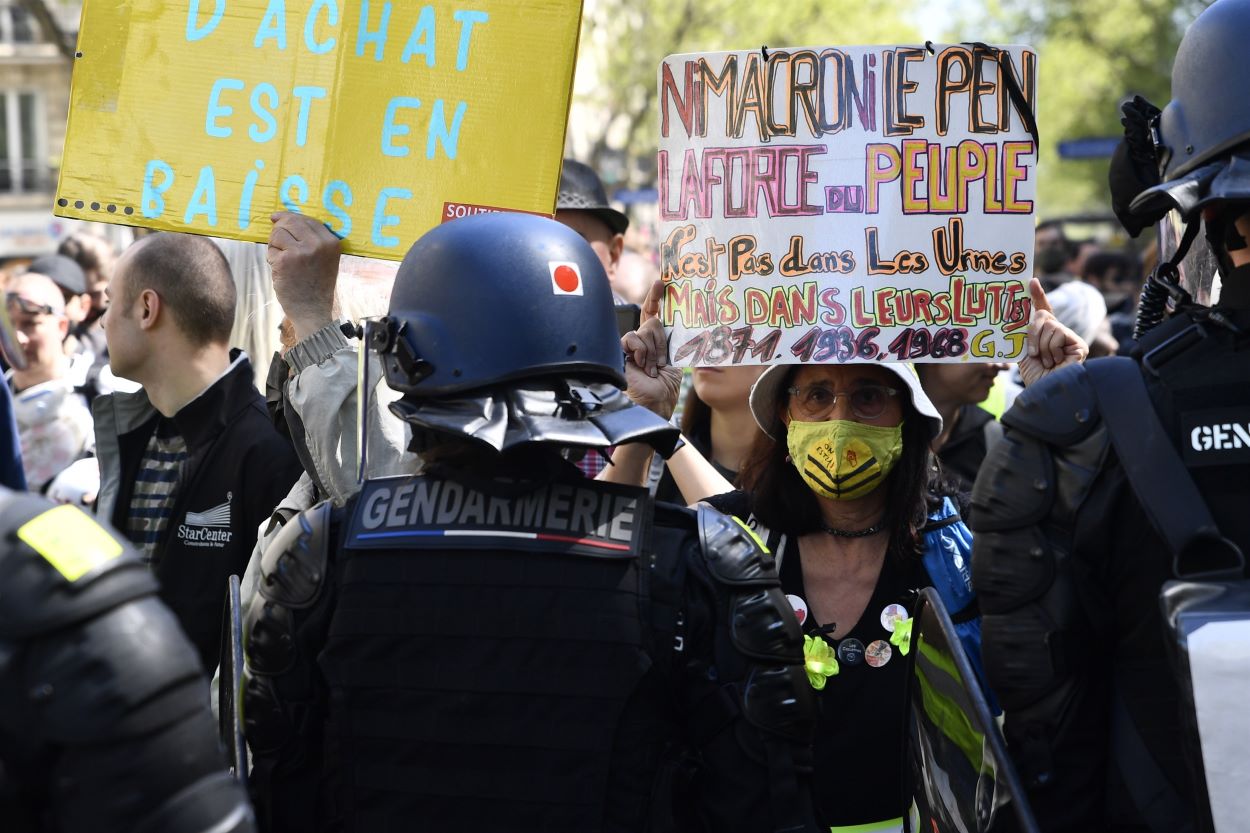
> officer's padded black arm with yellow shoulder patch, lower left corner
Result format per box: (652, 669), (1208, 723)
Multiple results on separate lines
(0, 492), (255, 833)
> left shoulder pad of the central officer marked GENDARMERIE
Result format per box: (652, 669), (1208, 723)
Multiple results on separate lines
(260, 500), (334, 609)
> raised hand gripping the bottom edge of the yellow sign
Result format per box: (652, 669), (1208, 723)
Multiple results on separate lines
(265, 211), (341, 340)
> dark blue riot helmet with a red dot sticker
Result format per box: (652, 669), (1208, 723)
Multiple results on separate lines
(370, 213), (625, 399)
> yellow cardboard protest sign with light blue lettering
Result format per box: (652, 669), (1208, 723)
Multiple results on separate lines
(54, 0), (581, 259)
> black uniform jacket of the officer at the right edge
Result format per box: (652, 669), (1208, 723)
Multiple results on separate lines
(973, 298), (1250, 833)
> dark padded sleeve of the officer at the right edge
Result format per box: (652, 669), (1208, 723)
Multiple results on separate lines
(973, 368), (1114, 833)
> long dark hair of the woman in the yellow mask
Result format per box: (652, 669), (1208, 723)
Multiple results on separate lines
(738, 367), (938, 558)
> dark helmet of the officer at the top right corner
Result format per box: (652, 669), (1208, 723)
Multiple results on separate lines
(1133, 0), (1250, 220)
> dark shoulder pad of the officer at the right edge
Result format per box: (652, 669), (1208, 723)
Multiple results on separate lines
(1003, 364), (1100, 448)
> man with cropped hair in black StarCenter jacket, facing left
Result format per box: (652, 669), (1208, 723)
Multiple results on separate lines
(93, 233), (300, 672)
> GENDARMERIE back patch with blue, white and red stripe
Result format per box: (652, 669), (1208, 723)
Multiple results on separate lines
(348, 477), (650, 558)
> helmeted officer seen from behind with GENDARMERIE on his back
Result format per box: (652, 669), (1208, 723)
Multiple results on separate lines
(244, 214), (815, 833)
